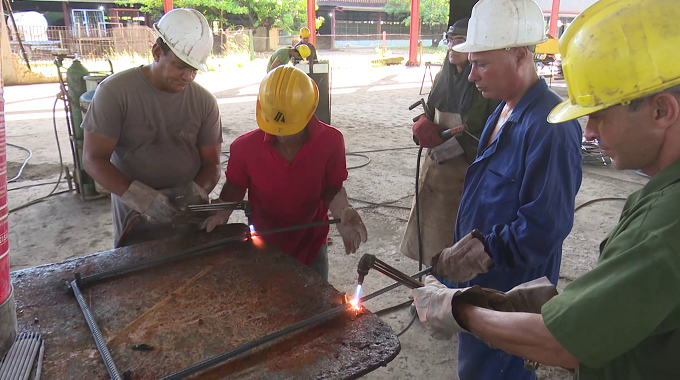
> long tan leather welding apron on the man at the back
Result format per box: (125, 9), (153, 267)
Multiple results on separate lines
(399, 109), (469, 265)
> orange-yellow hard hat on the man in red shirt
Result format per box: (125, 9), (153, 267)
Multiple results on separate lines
(255, 66), (319, 136)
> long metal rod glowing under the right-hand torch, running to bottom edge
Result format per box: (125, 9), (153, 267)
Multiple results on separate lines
(160, 268), (431, 380)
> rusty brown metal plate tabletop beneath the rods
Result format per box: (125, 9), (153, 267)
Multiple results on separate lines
(12, 225), (400, 380)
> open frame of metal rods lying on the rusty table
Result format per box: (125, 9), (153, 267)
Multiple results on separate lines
(67, 219), (418, 380)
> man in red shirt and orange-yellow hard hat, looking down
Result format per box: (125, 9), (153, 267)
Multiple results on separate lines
(204, 66), (367, 280)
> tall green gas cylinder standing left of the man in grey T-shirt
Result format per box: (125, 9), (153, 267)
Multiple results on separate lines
(66, 59), (97, 196)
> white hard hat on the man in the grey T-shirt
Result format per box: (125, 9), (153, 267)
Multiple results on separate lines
(153, 8), (213, 71)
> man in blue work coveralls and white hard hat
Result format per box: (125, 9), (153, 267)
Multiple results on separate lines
(416, 0), (582, 380)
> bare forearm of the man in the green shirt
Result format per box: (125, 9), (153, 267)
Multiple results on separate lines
(455, 304), (579, 369)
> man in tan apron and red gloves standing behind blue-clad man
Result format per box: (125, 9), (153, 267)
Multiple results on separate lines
(399, 18), (499, 263)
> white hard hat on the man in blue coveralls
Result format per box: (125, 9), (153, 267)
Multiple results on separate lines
(453, 0), (548, 53)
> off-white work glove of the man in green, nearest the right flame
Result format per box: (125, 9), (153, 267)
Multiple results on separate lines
(413, 276), (468, 340)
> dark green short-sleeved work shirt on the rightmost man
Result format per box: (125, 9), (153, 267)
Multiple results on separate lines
(542, 161), (680, 380)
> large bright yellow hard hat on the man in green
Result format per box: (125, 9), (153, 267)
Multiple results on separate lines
(548, 0), (680, 123)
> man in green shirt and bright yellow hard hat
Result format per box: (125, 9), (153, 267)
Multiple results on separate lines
(414, 0), (680, 380)
